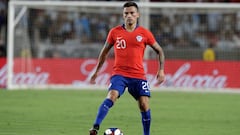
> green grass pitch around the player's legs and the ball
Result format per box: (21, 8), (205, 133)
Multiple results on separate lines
(0, 90), (240, 135)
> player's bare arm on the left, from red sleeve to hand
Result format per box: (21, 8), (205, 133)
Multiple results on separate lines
(90, 42), (113, 84)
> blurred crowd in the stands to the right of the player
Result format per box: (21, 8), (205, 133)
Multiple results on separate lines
(151, 12), (240, 49)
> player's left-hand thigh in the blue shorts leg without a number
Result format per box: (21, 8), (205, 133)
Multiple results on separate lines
(108, 75), (127, 98)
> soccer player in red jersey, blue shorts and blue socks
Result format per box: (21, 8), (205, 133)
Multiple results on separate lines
(90, 1), (165, 135)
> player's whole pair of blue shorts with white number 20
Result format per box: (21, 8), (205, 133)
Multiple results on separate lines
(108, 75), (151, 100)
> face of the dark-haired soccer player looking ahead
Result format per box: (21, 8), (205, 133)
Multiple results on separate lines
(123, 6), (139, 25)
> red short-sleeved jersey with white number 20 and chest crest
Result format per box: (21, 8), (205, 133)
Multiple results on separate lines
(107, 26), (156, 79)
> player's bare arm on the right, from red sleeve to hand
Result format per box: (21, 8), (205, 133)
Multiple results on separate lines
(151, 42), (165, 84)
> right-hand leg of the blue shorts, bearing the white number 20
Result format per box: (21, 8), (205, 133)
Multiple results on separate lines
(128, 79), (151, 100)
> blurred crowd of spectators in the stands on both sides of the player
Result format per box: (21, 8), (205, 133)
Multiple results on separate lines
(0, 0), (240, 56)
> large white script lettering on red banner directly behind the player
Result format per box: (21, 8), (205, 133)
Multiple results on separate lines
(77, 60), (227, 88)
